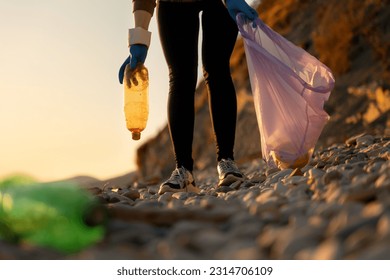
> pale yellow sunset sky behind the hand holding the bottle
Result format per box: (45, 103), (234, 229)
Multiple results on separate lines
(0, 0), (174, 181)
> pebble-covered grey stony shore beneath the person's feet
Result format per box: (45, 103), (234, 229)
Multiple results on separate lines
(0, 134), (390, 259)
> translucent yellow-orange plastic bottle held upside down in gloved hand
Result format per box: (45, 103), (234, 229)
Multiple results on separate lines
(123, 64), (149, 140)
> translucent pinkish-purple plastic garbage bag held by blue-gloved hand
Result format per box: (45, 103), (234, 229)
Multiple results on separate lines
(237, 14), (335, 169)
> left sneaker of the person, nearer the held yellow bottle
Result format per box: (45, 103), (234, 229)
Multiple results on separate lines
(158, 167), (200, 195)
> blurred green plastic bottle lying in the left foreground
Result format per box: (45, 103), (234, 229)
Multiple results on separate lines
(0, 176), (107, 253)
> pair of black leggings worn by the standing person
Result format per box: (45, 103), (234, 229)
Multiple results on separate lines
(157, 0), (238, 170)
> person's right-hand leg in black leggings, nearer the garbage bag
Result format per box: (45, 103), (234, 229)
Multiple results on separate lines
(202, 0), (238, 161)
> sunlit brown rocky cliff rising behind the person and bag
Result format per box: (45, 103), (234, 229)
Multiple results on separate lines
(137, 0), (390, 180)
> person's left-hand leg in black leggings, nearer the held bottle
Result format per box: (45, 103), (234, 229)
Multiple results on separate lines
(157, 2), (203, 171)
